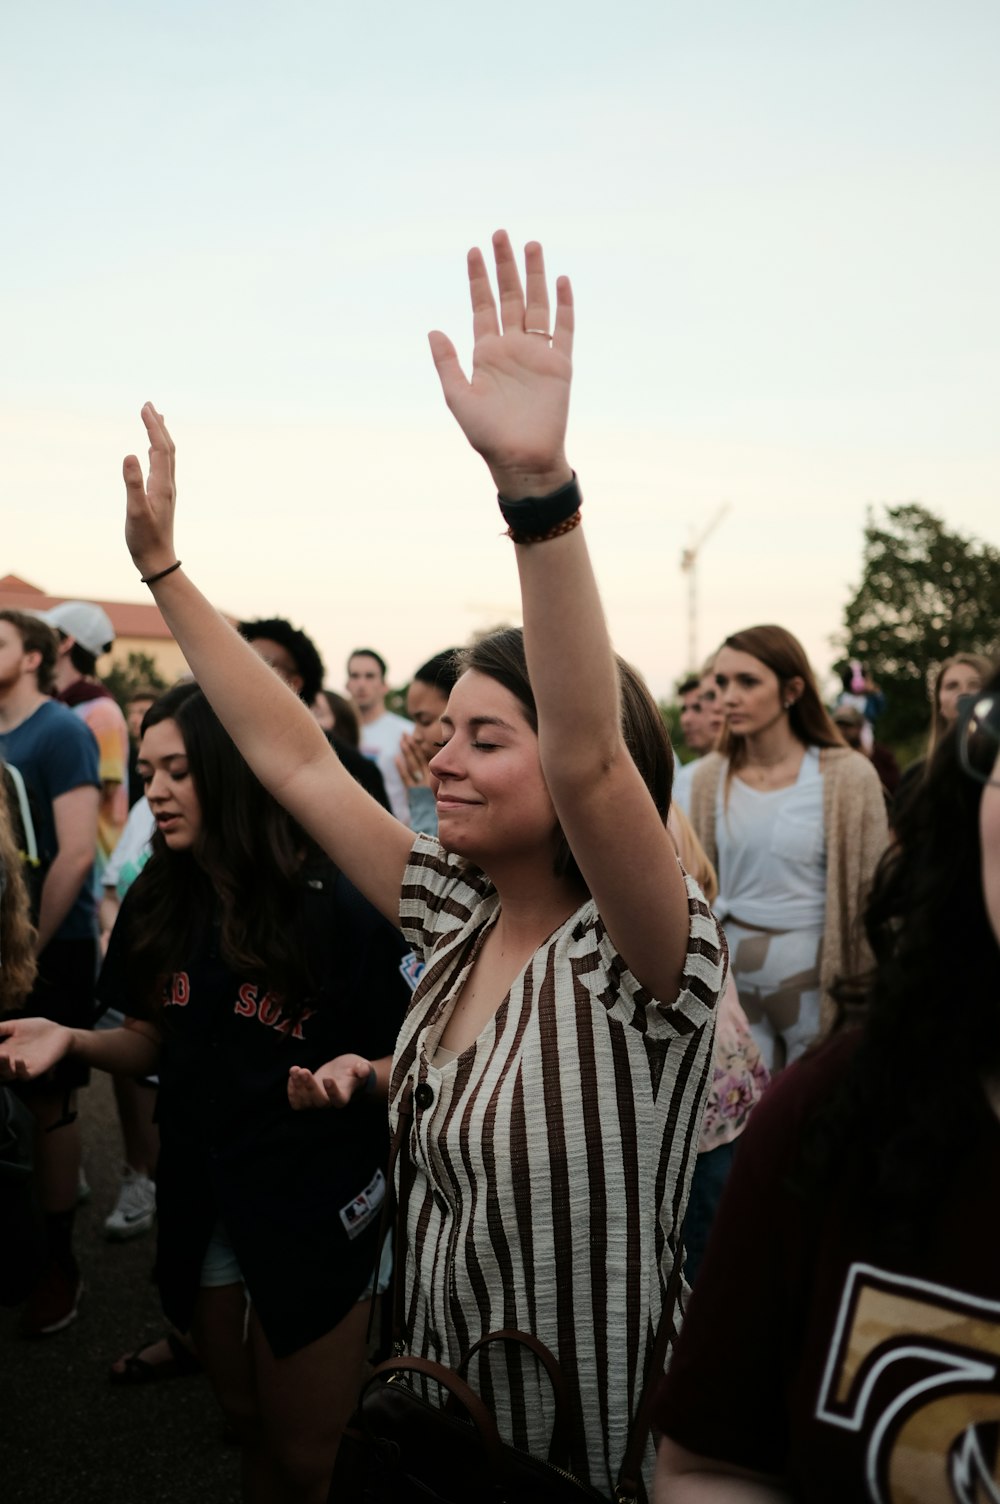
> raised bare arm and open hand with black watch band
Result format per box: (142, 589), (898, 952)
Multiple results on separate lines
(430, 232), (689, 1000)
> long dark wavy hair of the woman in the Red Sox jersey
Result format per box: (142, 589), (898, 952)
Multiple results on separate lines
(126, 684), (320, 1014)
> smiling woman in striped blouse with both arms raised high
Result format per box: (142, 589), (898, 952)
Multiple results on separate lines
(115, 232), (725, 1492)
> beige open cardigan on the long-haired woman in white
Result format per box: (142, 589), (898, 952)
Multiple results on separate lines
(690, 747), (889, 1029)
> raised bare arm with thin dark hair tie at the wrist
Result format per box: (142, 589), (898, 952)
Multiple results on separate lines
(123, 403), (412, 923)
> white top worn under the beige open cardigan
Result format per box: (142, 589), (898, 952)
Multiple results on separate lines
(714, 747), (827, 929)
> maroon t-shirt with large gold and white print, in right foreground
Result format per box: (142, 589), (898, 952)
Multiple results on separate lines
(656, 1041), (1000, 1504)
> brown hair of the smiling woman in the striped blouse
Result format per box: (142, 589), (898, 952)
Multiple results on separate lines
(457, 627), (674, 889)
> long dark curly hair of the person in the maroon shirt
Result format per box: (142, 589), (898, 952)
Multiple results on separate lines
(795, 672), (1000, 1253)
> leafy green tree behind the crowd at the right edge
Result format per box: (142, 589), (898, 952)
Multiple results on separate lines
(841, 502), (1000, 741)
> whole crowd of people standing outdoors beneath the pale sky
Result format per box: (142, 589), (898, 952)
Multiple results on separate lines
(0, 233), (1000, 1504)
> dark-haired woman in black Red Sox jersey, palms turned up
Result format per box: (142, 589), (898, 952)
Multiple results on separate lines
(0, 685), (408, 1504)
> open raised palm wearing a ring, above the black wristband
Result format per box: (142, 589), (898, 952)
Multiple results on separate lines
(429, 230), (573, 501)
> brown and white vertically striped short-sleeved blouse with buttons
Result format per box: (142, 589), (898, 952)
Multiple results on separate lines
(389, 836), (726, 1493)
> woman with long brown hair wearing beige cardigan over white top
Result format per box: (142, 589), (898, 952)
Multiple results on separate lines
(690, 626), (886, 1071)
